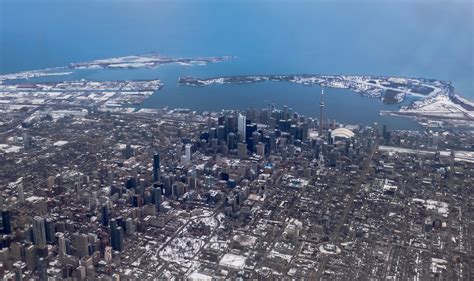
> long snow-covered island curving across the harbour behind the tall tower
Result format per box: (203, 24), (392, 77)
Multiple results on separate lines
(178, 74), (474, 129)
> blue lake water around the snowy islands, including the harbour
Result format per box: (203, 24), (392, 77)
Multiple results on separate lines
(0, 0), (474, 128)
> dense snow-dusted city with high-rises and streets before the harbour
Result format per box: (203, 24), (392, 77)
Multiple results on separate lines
(0, 102), (474, 280)
